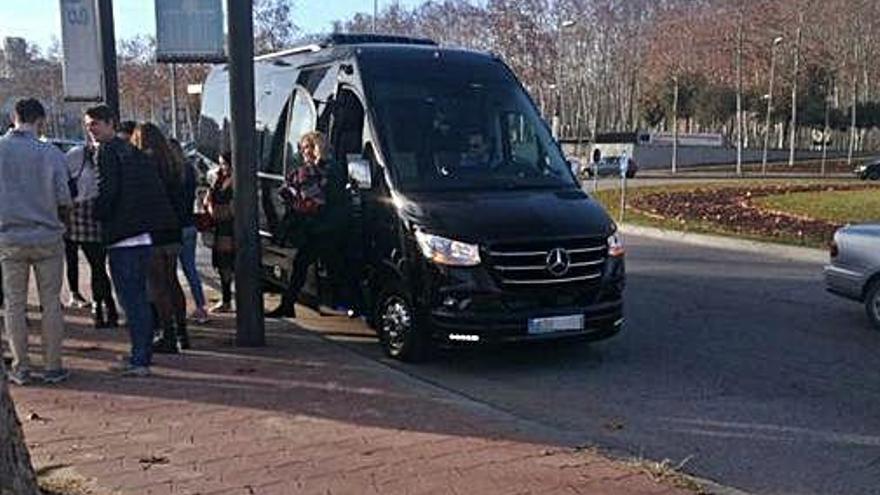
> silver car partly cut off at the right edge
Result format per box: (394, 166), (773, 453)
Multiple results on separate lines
(825, 224), (880, 330)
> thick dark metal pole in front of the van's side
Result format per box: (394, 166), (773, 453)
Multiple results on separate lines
(226, 0), (266, 346)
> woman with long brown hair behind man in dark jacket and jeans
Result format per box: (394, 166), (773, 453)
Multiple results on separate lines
(131, 123), (189, 354)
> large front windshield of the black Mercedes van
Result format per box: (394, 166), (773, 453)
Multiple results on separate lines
(365, 55), (576, 192)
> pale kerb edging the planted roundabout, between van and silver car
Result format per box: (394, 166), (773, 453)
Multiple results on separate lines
(619, 223), (828, 265)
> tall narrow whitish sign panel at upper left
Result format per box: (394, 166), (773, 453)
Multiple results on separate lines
(61, 0), (104, 101)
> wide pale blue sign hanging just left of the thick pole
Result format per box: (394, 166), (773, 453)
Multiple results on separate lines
(156, 0), (226, 63)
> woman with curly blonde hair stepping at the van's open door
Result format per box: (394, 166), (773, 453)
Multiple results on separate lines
(266, 132), (347, 318)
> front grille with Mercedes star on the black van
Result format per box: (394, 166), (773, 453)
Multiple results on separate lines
(488, 237), (608, 289)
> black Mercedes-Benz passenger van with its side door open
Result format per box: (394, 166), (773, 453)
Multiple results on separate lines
(198, 35), (625, 360)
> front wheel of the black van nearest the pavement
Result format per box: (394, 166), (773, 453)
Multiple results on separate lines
(376, 284), (429, 362)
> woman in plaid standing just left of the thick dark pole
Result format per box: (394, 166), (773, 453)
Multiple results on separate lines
(205, 151), (235, 313)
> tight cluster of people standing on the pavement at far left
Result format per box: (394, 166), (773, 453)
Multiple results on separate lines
(0, 99), (214, 385)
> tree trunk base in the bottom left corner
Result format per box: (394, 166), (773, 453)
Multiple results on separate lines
(0, 362), (40, 495)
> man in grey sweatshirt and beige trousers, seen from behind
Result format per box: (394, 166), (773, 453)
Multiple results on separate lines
(0, 98), (71, 385)
